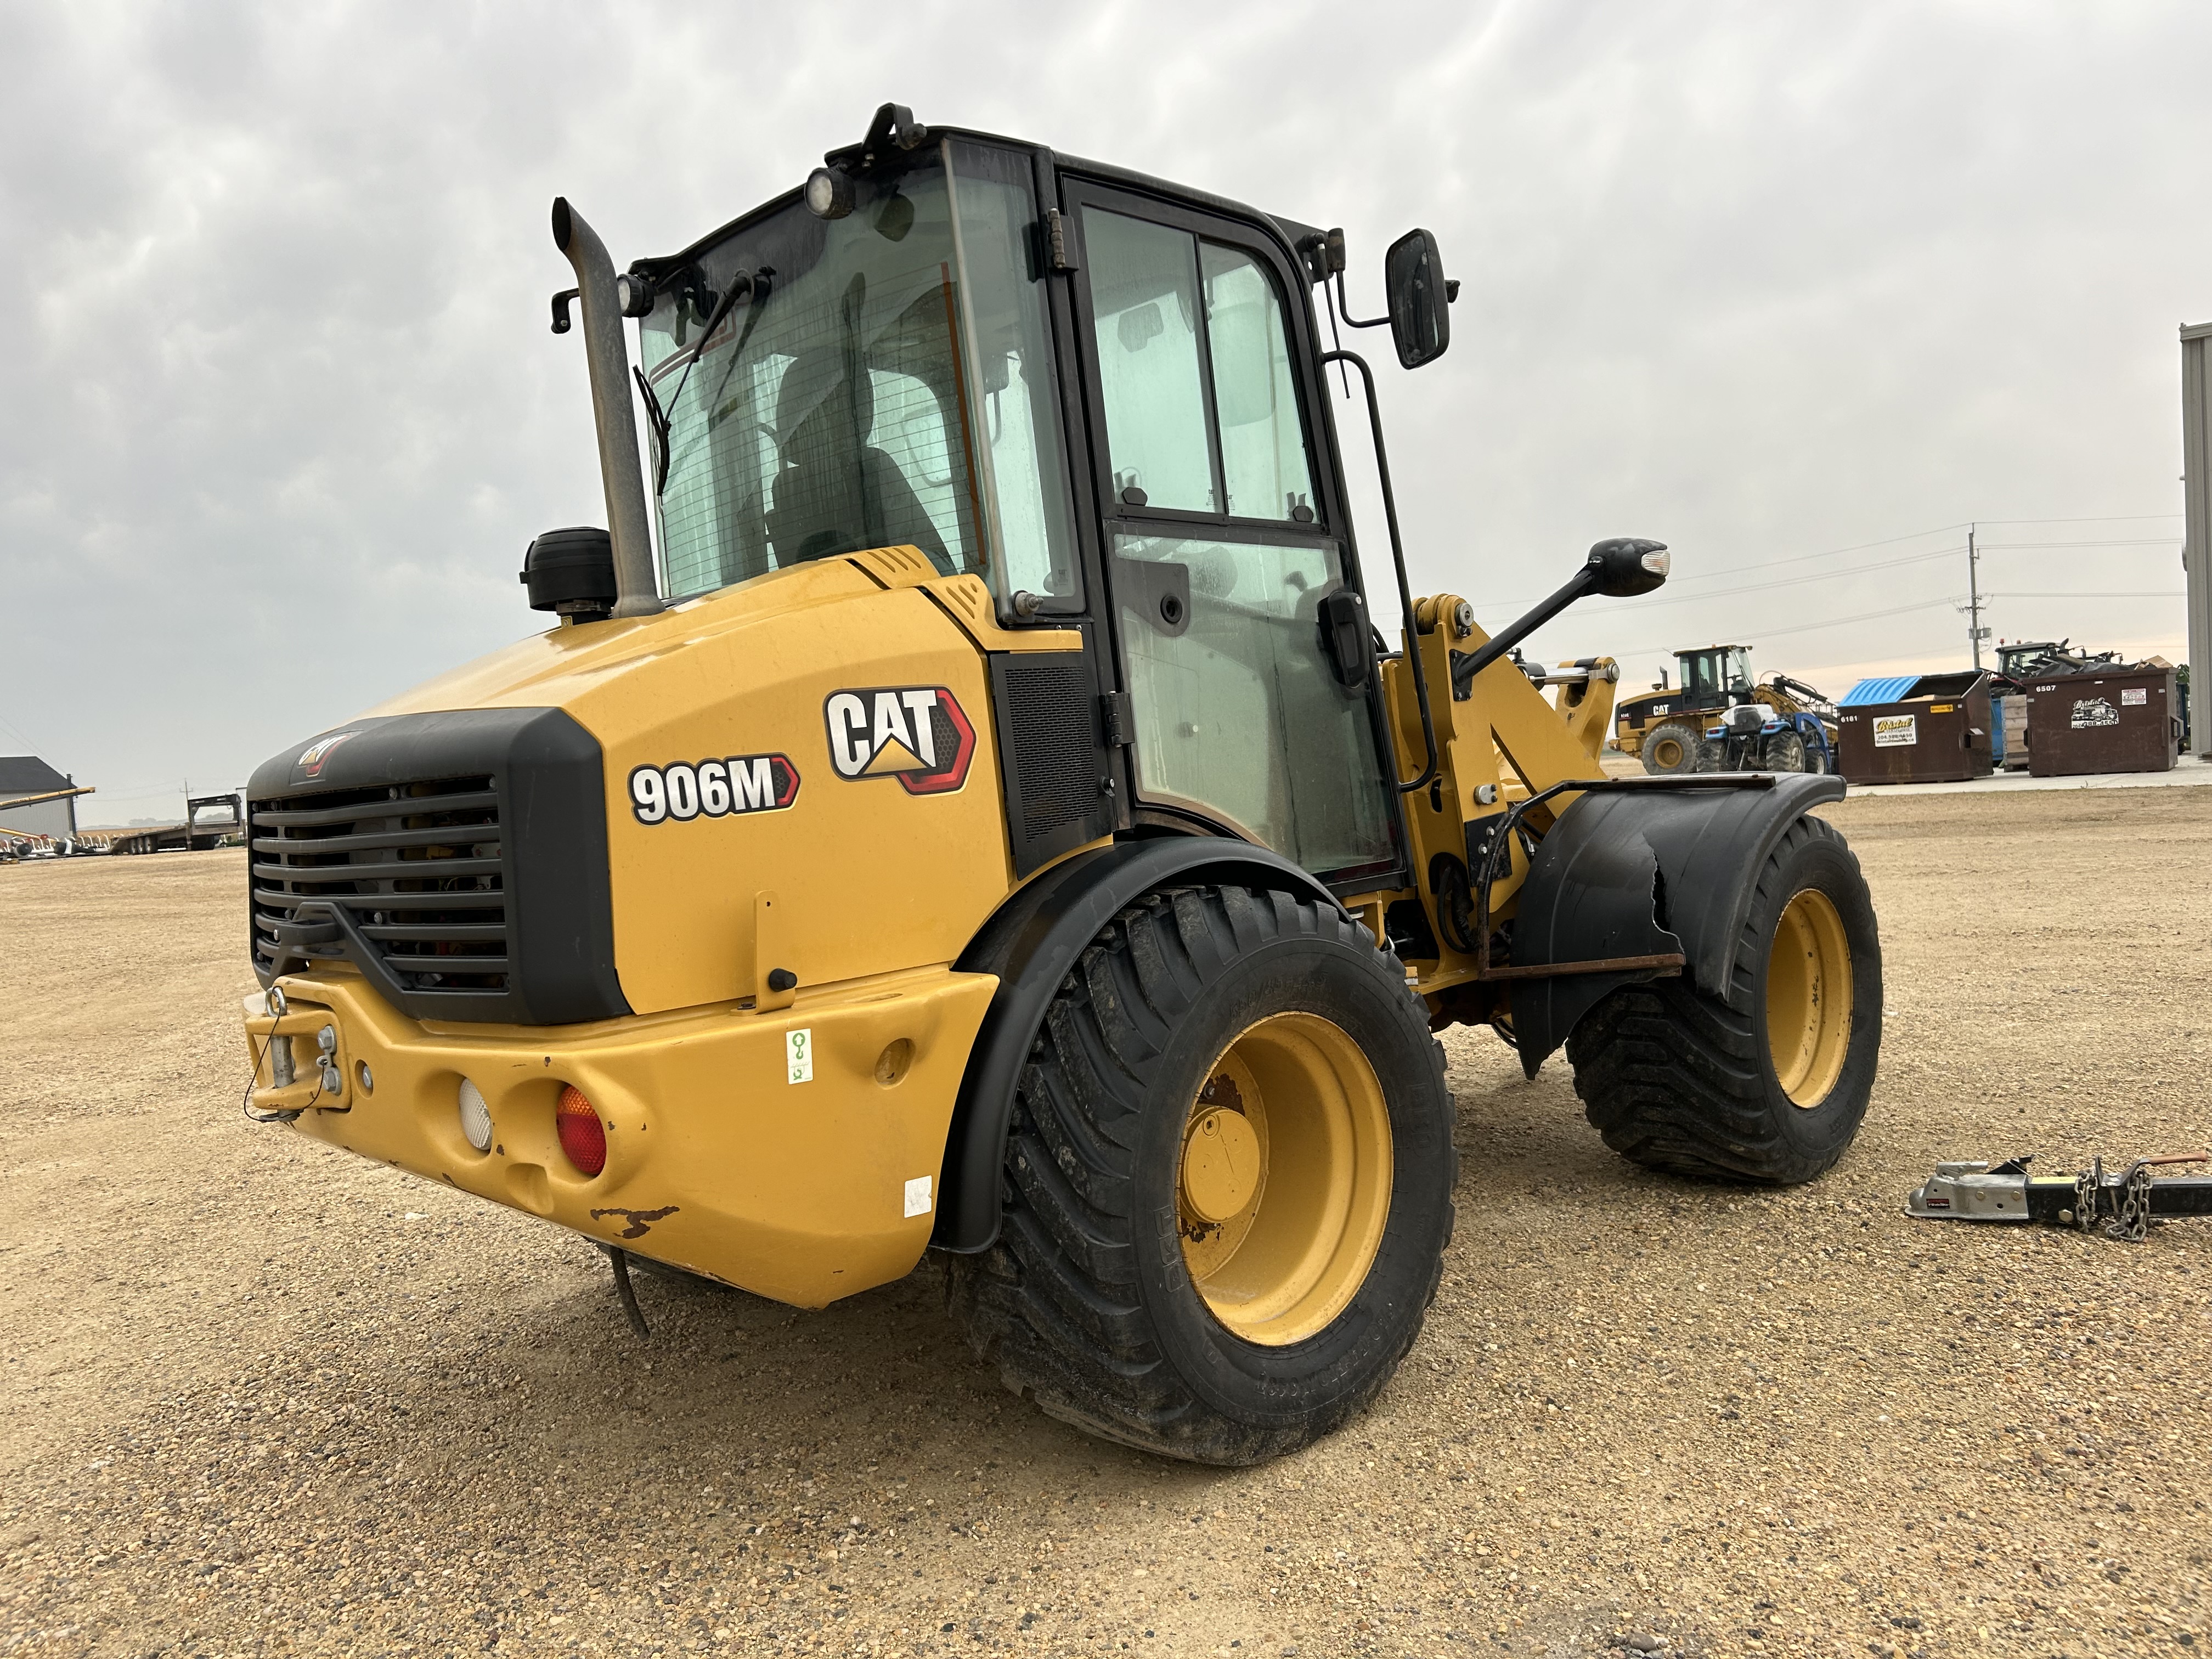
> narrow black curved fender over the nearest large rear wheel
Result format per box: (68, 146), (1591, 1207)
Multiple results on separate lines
(929, 836), (1340, 1252)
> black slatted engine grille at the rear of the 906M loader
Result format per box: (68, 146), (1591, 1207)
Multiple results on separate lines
(250, 776), (513, 995)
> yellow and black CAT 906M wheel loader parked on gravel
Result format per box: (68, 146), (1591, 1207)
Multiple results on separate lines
(246, 106), (1882, 1462)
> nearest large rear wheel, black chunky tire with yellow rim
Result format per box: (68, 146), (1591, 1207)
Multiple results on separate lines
(947, 887), (1458, 1464)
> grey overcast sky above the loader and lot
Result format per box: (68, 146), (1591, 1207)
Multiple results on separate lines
(0, 0), (2212, 823)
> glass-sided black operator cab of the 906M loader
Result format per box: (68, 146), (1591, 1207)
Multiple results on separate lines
(617, 106), (1449, 891)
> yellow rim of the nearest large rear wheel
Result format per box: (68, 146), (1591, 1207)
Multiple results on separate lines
(1175, 1013), (1391, 1347)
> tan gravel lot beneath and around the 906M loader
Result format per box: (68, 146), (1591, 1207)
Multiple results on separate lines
(0, 789), (2212, 1659)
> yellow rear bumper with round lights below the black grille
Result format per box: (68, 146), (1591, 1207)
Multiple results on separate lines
(246, 967), (997, 1307)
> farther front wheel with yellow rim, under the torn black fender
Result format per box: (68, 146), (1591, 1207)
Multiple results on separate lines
(1566, 819), (1882, 1186)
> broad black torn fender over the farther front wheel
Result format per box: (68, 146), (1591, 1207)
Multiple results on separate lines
(1513, 772), (1845, 1077)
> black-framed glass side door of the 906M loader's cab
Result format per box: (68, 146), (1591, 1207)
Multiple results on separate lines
(1066, 186), (1398, 885)
